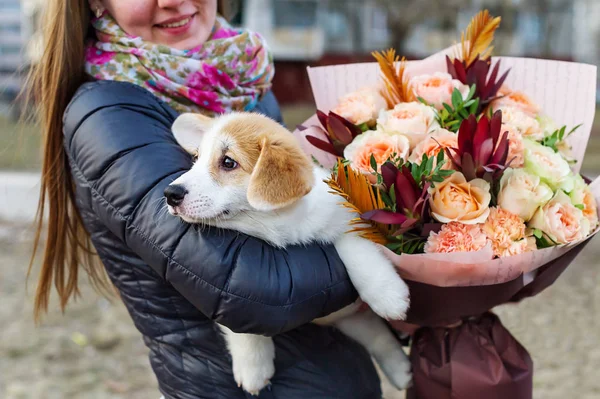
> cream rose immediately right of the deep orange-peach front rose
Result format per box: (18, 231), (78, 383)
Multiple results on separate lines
(498, 168), (552, 222)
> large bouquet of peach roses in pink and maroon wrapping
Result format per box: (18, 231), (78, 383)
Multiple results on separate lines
(296, 11), (600, 398)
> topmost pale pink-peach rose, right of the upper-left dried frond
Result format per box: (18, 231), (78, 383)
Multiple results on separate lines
(408, 72), (469, 110)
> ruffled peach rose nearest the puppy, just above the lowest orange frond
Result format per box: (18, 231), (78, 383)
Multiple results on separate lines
(344, 130), (410, 174)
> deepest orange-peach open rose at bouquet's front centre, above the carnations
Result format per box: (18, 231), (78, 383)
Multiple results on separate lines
(429, 172), (492, 224)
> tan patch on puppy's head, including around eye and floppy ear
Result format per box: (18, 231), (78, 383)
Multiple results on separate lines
(206, 113), (314, 209)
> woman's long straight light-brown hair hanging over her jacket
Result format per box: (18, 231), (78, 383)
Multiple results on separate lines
(26, 0), (237, 321)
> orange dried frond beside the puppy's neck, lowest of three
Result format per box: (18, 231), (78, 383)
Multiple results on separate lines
(326, 160), (391, 245)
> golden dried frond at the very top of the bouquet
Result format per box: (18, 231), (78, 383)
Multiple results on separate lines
(461, 10), (502, 67)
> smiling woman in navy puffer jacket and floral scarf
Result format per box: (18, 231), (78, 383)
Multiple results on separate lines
(27, 0), (381, 399)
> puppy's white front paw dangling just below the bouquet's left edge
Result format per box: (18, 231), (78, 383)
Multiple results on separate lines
(360, 277), (410, 320)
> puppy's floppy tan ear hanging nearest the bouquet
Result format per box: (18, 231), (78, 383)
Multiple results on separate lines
(248, 137), (314, 211)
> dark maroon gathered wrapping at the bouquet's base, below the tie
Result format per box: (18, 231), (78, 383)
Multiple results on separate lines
(406, 313), (533, 399)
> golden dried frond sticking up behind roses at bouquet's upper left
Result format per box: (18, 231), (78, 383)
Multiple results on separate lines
(371, 49), (415, 108)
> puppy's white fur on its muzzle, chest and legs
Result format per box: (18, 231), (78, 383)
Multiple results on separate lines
(169, 114), (410, 394)
